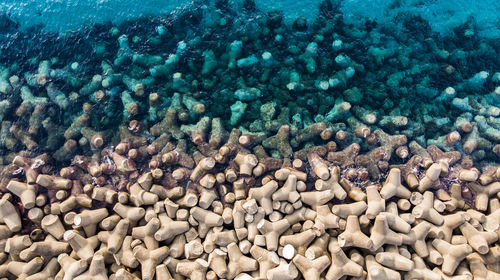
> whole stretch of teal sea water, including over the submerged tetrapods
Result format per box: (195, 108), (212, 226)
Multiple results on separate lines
(0, 0), (500, 167)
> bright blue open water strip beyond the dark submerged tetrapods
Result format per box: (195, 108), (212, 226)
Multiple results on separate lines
(0, 0), (500, 37)
